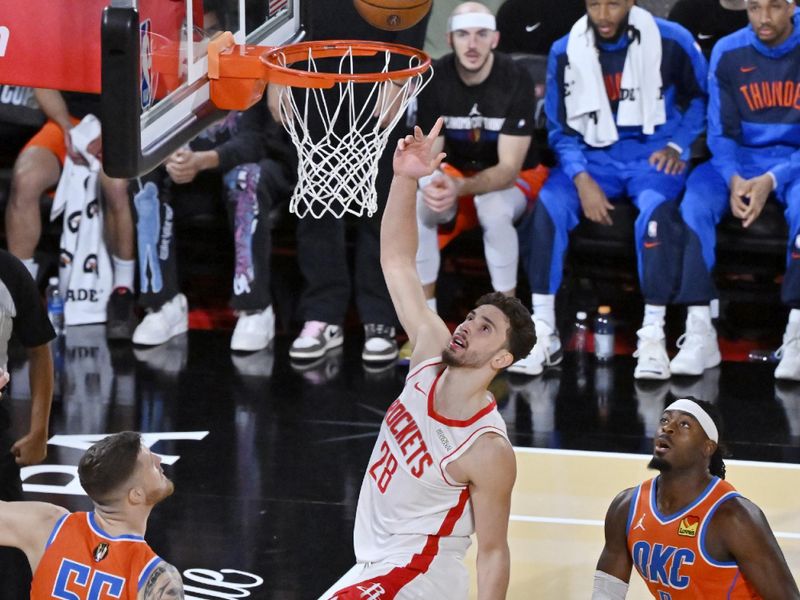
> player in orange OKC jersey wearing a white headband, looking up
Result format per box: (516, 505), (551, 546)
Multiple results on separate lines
(592, 398), (800, 600)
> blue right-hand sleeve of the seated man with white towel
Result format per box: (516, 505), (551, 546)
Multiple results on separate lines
(672, 27), (708, 158)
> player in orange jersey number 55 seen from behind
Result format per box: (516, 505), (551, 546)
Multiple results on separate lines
(0, 431), (184, 600)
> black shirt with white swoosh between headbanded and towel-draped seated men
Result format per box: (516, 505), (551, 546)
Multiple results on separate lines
(497, 0), (586, 56)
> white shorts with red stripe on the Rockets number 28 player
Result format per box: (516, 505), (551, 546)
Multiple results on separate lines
(319, 553), (469, 600)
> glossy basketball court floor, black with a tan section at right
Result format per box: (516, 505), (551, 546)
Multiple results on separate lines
(0, 326), (800, 600)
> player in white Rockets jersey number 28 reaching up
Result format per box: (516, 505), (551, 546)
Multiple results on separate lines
(321, 119), (535, 600)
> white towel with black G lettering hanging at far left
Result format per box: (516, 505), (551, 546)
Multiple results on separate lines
(50, 115), (113, 325)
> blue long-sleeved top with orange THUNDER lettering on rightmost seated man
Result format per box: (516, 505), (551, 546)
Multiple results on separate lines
(708, 14), (800, 188)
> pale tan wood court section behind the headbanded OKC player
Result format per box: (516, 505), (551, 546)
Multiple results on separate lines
(467, 448), (800, 600)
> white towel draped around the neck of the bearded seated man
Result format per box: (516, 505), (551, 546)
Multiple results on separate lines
(564, 6), (667, 148)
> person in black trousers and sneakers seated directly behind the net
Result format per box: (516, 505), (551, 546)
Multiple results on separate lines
(280, 0), (427, 368)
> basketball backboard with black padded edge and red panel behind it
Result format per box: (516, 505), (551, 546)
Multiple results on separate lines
(0, 0), (303, 177)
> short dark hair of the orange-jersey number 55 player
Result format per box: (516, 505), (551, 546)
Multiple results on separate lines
(78, 431), (142, 504)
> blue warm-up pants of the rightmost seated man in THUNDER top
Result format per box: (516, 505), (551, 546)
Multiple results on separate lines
(678, 162), (800, 308)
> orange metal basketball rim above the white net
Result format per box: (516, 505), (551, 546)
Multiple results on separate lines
(260, 40), (431, 88)
